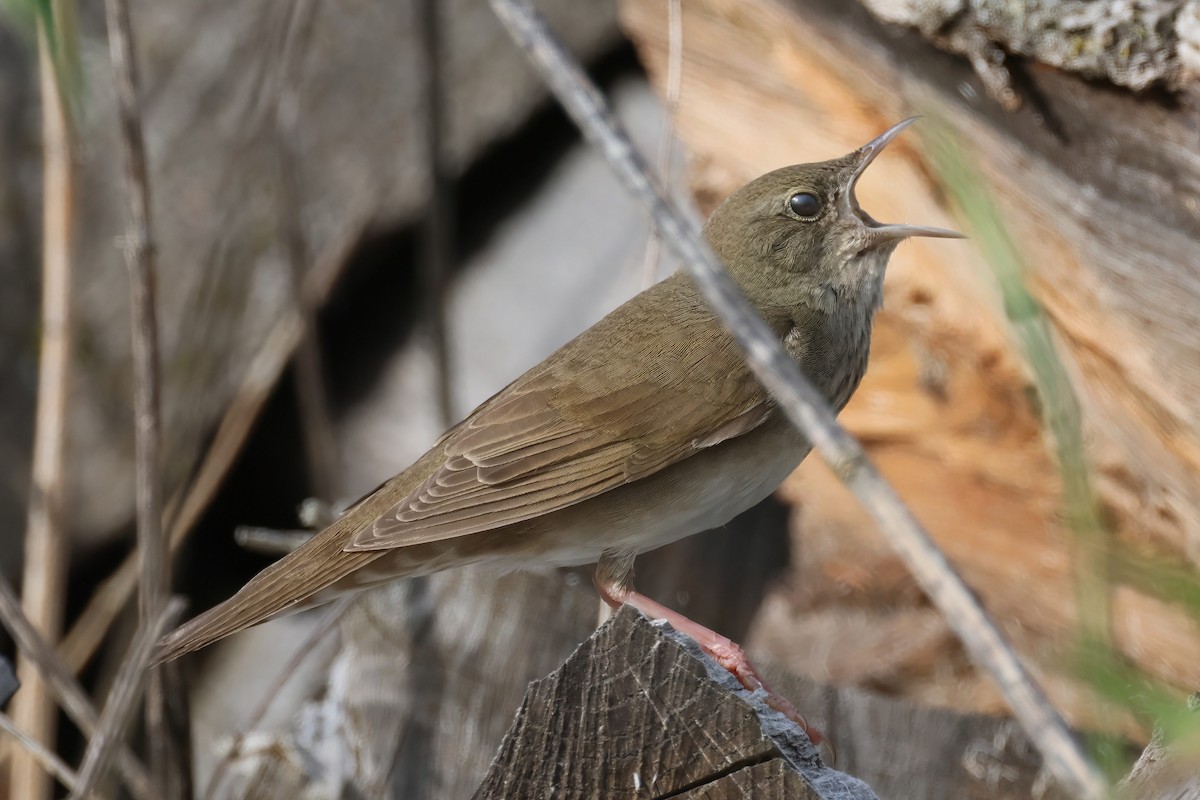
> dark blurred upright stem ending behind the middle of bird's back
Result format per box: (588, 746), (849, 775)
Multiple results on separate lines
(416, 0), (458, 428)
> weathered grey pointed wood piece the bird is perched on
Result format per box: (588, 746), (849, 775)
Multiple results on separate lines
(474, 606), (876, 800)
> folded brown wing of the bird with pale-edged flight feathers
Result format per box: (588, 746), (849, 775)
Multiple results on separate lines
(346, 297), (770, 551)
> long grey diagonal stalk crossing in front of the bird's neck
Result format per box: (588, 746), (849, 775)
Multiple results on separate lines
(491, 0), (1106, 799)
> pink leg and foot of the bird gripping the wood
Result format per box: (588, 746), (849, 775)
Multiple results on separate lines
(592, 552), (832, 750)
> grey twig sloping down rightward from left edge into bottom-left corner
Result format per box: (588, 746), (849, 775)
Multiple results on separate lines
(0, 572), (155, 800)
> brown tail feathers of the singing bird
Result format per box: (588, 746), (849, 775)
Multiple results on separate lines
(154, 515), (384, 663)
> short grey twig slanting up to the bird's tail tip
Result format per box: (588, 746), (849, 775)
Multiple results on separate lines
(71, 597), (184, 800)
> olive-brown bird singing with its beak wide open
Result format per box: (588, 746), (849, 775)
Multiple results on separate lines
(157, 120), (959, 734)
